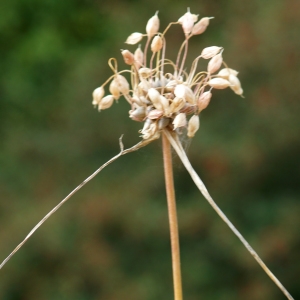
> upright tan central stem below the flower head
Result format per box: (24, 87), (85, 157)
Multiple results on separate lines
(162, 134), (182, 300)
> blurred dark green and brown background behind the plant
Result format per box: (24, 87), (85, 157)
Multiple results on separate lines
(0, 0), (300, 300)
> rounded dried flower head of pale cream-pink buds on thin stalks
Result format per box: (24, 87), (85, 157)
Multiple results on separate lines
(92, 11), (243, 139)
